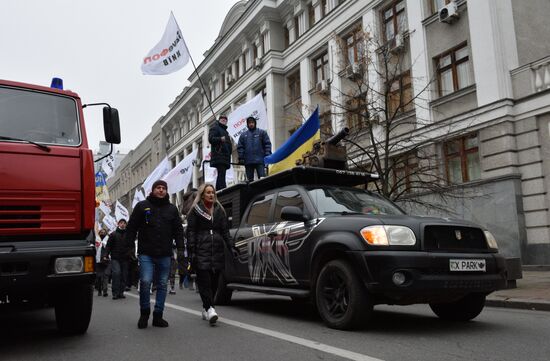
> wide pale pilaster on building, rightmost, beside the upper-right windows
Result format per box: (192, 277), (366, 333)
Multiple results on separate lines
(468, 0), (519, 107)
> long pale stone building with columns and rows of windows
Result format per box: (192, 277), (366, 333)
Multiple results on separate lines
(105, 0), (550, 264)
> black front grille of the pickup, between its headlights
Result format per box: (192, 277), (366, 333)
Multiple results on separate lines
(424, 226), (487, 252)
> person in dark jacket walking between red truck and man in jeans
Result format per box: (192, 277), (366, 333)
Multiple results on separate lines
(106, 219), (130, 300)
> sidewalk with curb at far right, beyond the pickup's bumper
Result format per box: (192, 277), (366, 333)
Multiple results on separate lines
(486, 266), (550, 311)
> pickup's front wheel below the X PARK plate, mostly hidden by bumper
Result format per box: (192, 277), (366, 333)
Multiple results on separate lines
(430, 293), (485, 321)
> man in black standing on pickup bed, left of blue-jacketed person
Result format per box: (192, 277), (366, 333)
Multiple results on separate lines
(208, 115), (233, 190)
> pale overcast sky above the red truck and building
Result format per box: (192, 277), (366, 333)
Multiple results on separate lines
(0, 0), (244, 152)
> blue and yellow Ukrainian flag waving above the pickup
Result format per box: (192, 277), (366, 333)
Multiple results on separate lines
(264, 107), (321, 174)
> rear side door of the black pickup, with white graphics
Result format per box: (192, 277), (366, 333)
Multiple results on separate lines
(235, 193), (274, 285)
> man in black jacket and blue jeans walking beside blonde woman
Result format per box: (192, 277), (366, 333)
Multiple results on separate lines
(126, 180), (184, 328)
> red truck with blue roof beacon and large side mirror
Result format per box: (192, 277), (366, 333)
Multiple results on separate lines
(0, 78), (120, 334)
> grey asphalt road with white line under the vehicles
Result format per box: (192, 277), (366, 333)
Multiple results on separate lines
(0, 290), (550, 361)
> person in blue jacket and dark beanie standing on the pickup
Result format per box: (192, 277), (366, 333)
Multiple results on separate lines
(237, 117), (271, 182)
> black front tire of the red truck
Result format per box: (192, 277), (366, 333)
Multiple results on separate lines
(55, 285), (93, 335)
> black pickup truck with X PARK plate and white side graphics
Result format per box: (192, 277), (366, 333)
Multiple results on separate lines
(215, 166), (506, 329)
